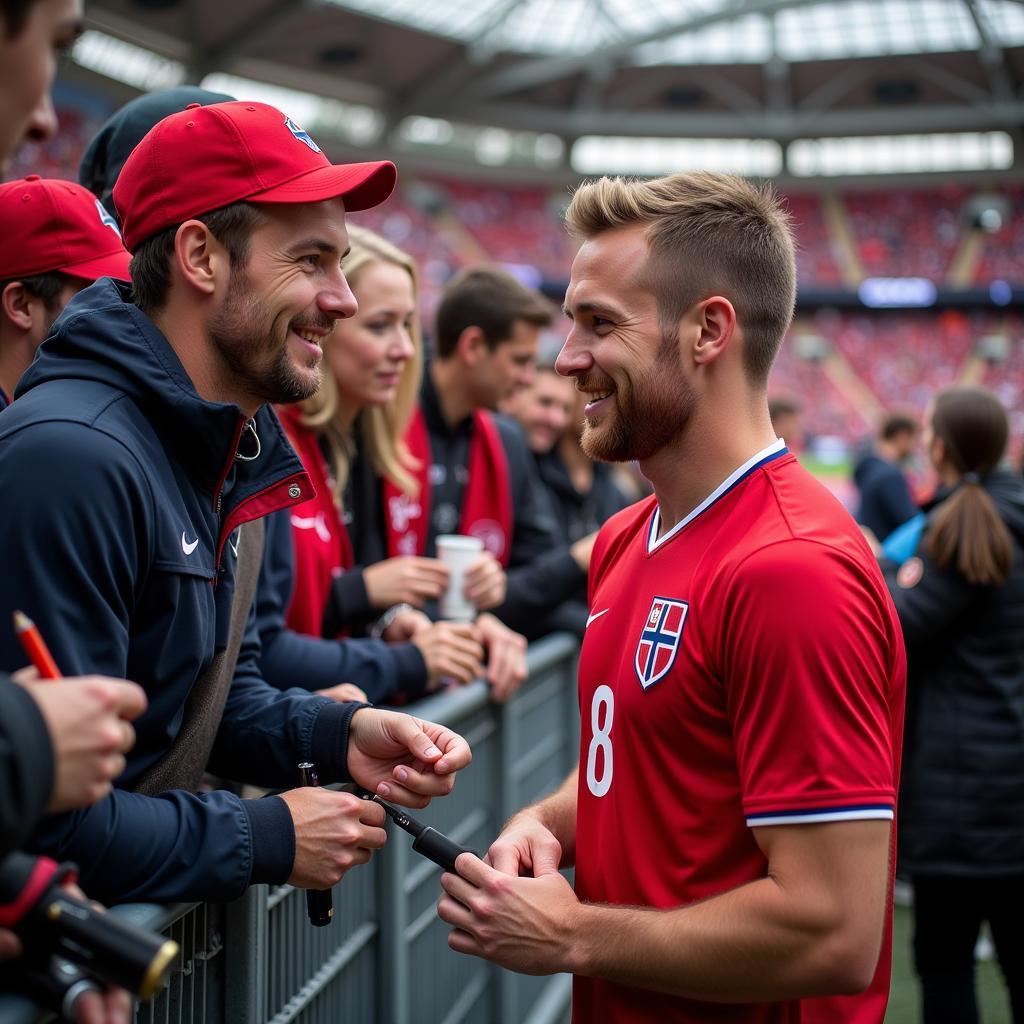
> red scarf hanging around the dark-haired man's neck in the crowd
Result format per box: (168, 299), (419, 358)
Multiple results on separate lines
(384, 409), (512, 566)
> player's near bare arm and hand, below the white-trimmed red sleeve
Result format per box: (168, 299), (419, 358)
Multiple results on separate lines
(438, 815), (891, 1002)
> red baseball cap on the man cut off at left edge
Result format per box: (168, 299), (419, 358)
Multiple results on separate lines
(0, 174), (131, 281)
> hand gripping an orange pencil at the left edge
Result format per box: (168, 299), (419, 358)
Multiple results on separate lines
(15, 673), (145, 811)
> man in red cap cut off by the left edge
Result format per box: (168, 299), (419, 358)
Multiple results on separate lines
(0, 174), (131, 410)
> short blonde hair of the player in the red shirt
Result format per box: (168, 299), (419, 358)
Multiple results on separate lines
(565, 171), (797, 385)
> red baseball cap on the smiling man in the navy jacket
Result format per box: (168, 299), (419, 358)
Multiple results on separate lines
(114, 101), (397, 252)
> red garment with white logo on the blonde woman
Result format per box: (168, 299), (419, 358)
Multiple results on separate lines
(278, 406), (353, 637)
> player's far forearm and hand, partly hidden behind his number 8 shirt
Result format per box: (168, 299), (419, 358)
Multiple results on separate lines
(484, 771), (579, 877)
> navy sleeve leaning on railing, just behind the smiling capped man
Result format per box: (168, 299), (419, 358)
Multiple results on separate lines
(256, 509), (427, 702)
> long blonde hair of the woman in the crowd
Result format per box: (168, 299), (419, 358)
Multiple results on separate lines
(301, 224), (423, 499)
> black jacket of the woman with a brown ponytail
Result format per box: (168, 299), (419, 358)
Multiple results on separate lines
(884, 473), (1024, 876)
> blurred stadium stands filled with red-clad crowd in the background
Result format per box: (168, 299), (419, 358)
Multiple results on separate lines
(8, 110), (1024, 456)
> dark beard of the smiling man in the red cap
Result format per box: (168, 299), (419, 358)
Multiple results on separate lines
(208, 267), (321, 406)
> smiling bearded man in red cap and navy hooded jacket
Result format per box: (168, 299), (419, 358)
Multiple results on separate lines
(0, 102), (470, 901)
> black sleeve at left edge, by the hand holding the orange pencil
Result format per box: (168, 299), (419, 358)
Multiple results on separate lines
(0, 677), (53, 857)
